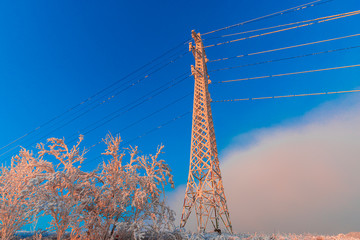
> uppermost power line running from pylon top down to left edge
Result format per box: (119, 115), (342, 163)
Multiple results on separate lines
(0, 39), (191, 156)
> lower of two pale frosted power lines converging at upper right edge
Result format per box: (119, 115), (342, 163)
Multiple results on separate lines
(204, 10), (360, 48)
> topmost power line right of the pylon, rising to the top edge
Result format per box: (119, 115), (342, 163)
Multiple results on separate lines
(202, 0), (332, 36)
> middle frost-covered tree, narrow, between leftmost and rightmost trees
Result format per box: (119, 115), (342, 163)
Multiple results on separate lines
(36, 136), (90, 240)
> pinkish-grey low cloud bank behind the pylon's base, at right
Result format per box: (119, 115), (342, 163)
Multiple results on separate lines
(170, 97), (360, 234)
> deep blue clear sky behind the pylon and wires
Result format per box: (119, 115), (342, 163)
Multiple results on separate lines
(0, 0), (360, 232)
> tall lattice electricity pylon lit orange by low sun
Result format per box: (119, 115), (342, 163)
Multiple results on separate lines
(180, 31), (232, 233)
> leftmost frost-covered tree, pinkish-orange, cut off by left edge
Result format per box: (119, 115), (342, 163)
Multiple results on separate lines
(0, 149), (52, 240)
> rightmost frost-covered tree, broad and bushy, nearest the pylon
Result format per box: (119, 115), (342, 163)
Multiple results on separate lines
(82, 134), (174, 239)
